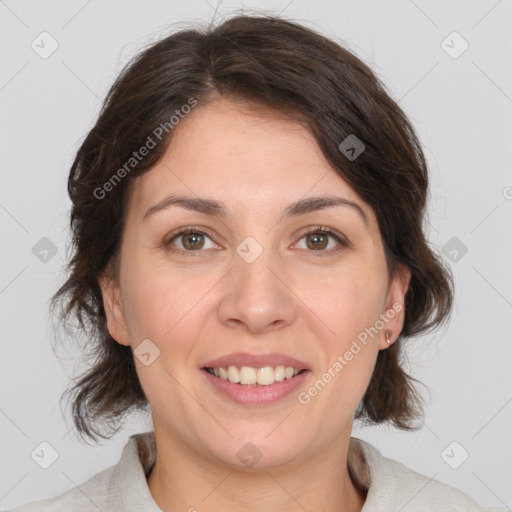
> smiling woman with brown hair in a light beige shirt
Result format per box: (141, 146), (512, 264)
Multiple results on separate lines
(16, 12), (492, 512)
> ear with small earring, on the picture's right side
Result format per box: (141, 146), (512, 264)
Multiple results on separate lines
(379, 263), (411, 350)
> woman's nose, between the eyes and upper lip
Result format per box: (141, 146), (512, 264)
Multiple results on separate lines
(218, 246), (298, 334)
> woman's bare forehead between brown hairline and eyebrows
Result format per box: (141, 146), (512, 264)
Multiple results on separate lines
(126, 99), (372, 223)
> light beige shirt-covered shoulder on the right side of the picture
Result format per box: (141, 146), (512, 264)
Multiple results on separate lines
(349, 438), (498, 512)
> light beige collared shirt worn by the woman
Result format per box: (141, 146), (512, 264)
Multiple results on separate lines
(12, 432), (496, 512)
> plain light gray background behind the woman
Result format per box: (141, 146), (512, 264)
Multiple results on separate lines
(0, 0), (512, 508)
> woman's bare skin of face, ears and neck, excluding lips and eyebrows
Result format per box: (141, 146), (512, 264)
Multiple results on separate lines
(101, 99), (410, 512)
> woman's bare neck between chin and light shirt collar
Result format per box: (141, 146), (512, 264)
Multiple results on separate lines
(148, 428), (365, 512)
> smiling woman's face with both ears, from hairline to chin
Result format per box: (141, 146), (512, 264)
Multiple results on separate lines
(101, 99), (409, 468)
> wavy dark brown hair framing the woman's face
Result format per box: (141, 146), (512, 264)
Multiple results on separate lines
(52, 15), (453, 439)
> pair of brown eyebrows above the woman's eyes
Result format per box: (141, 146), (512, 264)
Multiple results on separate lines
(142, 194), (368, 226)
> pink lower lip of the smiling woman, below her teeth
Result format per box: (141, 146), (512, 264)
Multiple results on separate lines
(201, 369), (310, 405)
